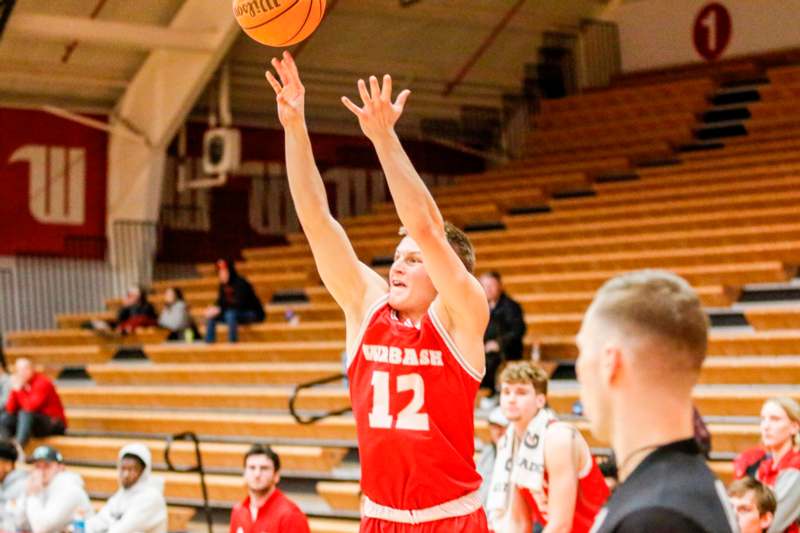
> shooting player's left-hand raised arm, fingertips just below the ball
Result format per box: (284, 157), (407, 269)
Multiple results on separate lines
(266, 52), (387, 320)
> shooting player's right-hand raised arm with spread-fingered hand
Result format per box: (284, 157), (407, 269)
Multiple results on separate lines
(342, 74), (489, 371)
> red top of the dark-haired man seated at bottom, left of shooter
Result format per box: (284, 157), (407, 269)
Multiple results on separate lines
(230, 488), (310, 533)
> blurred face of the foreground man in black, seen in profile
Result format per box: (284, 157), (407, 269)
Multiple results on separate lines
(575, 310), (610, 441)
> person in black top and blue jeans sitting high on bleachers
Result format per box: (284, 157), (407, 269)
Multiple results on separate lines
(205, 259), (266, 343)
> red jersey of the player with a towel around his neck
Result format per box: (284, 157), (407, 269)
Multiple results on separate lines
(518, 457), (610, 533)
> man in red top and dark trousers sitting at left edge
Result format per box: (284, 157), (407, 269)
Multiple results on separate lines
(0, 358), (67, 448)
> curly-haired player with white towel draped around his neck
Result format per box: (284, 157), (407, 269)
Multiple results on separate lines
(486, 361), (609, 533)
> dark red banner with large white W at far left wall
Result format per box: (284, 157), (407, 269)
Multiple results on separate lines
(0, 108), (108, 258)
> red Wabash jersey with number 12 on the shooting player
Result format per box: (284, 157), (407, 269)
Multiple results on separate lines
(347, 296), (481, 510)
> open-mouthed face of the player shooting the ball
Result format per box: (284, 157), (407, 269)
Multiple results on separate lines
(389, 237), (436, 311)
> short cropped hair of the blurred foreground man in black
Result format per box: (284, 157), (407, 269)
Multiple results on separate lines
(589, 270), (708, 372)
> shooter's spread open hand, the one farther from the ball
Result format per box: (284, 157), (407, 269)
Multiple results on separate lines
(342, 74), (411, 142)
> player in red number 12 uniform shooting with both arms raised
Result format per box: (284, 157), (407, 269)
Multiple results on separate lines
(267, 53), (489, 533)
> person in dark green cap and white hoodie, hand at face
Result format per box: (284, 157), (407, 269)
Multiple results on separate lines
(22, 446), (92, 533)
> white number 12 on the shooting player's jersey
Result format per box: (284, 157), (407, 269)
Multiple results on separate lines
(369, 370), (429, 431)
